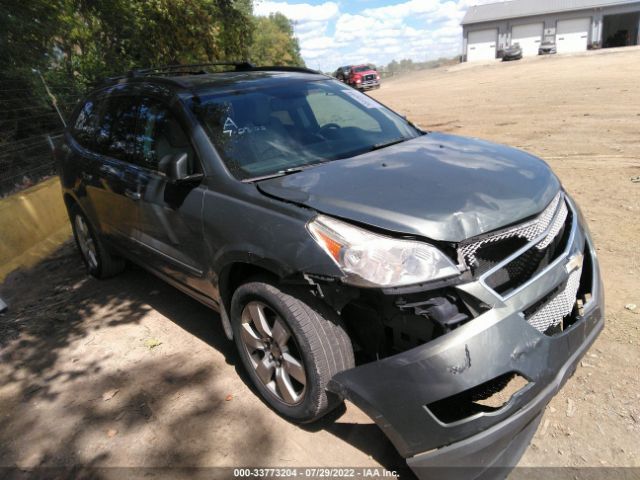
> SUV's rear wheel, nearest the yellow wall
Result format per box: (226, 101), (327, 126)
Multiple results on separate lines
(69, 206), (125, 279)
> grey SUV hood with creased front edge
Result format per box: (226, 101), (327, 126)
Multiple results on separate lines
(258, 133), (560, 242)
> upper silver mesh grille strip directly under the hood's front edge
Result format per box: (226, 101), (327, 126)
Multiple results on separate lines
(460, 192), (568, 266)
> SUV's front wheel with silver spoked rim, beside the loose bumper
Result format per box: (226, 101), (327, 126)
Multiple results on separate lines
(231, 278), (355, 423)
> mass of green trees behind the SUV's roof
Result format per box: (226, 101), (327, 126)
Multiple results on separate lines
(0, 0), (304, 144)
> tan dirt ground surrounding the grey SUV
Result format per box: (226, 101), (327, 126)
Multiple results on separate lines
(0, 49), (640, 478)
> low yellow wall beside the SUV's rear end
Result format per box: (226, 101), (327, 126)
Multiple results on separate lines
(0, 177), (71, 282)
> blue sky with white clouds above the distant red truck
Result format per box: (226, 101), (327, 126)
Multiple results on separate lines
(254, 0), (486, 71)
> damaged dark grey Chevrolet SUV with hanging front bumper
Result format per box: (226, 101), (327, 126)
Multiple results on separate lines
(56, 63), (604, 478)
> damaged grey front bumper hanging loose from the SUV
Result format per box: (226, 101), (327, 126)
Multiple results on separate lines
(329, 196), (604, 479)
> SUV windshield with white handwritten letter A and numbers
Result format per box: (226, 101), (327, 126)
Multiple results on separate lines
(191, 80), (422, 180)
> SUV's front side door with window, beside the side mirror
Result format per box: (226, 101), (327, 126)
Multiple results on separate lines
(127, 96), (212, 294)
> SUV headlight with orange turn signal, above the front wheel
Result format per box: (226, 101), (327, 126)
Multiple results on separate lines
(307, 215), (460, 287)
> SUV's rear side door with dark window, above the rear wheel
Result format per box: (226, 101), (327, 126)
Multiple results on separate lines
(87, 94), (139, 249)
